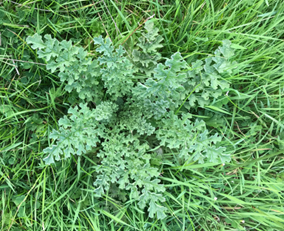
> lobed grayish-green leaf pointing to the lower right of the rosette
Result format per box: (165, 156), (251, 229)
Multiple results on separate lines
(156, 112), (231, 163)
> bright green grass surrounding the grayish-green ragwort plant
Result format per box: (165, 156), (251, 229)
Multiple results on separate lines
(0, 0), (284, 231)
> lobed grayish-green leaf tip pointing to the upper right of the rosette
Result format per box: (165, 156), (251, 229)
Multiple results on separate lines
(185, 40), (234, 109)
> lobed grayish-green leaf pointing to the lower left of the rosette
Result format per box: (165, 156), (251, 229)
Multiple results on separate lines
(43, 104), (105, 164)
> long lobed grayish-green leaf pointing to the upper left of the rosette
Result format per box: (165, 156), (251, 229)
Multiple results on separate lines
(27, 34), (102, 101)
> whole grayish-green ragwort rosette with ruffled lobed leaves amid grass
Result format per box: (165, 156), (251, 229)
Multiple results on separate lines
(27, 22), (235, 219)
